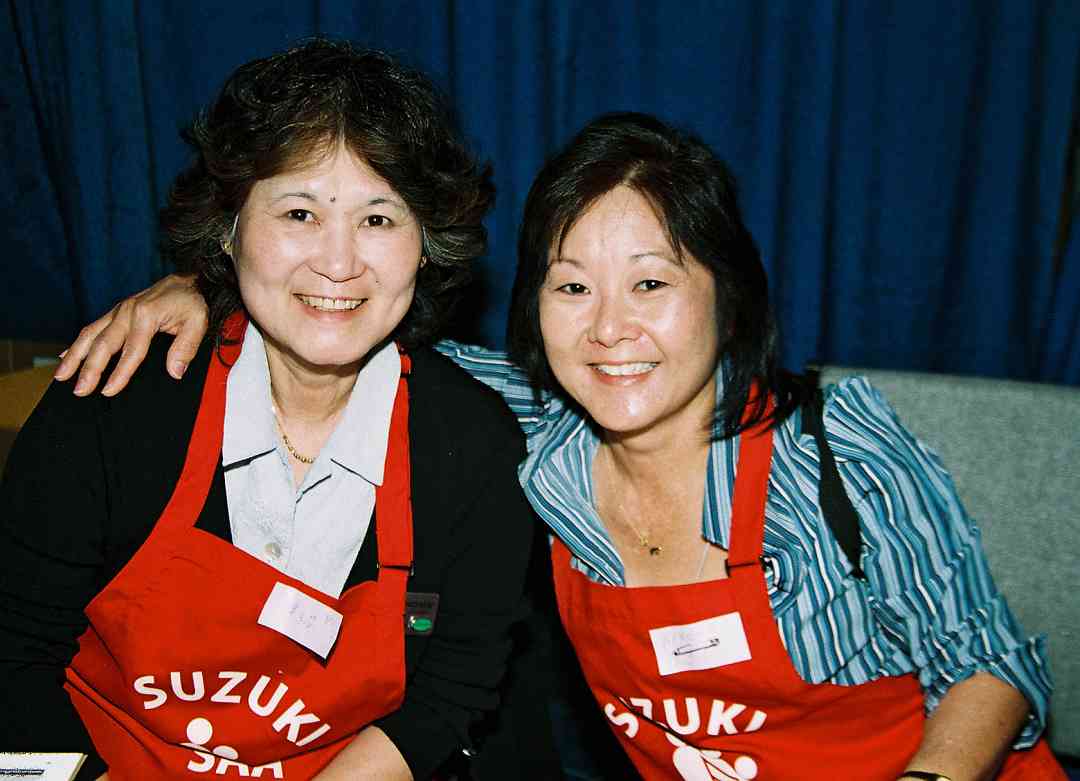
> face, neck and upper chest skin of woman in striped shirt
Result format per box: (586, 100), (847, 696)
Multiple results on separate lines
(539, 186), (724, 584)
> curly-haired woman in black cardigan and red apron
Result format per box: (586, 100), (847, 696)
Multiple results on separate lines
(0, 40), (534, 779)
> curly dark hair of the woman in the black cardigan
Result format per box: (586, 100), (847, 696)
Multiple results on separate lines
(161, 39), (495, 348)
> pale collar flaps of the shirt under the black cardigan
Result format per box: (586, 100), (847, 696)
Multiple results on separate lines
(221, 323), (401, 485)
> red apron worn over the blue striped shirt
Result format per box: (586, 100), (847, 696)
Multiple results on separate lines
(552, 406), (1065, 781)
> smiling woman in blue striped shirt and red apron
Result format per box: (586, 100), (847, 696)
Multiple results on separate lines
(503, 115), (1063, 781)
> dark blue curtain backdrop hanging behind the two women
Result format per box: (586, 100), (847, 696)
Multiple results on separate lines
(6, 0), (1080, 383)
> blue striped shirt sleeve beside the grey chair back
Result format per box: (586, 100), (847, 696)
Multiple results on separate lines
(826, 378), (1051, 749)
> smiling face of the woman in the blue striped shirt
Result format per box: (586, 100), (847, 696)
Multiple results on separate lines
(540, 187), (720, 441)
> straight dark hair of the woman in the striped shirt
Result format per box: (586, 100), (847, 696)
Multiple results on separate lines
(507, 112), (810, 437)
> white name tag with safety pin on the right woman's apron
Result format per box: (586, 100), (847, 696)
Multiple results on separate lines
(649, 612), (751, 675)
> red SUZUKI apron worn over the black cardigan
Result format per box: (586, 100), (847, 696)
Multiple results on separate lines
(65, 319), (413, 781)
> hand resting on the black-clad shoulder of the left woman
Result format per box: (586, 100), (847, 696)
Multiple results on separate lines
(55, 274), (208, 396)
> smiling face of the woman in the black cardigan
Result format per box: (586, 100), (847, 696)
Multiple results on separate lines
(228, 149), (421, 378)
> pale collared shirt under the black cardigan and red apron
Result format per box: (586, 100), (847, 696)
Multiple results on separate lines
(221, 323), (401, 596)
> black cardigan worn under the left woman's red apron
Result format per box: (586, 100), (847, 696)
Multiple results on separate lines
(0, 338), (536, 779)
